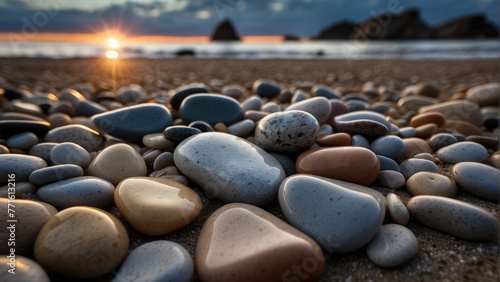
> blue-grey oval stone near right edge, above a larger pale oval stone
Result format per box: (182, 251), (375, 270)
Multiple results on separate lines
(436, 141), (489, 164)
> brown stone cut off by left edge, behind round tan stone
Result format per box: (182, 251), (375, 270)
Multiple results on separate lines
(0, 198), (57, 258)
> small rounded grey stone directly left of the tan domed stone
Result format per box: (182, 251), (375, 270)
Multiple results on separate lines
(50, 142), (91, 168)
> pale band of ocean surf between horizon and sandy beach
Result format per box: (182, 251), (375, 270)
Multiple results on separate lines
(0, 40), (500, 60)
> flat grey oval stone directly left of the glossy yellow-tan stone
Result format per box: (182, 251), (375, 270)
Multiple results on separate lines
(36, 176), (115, 210)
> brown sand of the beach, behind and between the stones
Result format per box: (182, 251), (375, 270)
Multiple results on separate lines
(0, 58), (500, 281)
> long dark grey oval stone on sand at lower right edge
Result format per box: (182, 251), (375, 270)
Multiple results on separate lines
(406, 196), (499, 241)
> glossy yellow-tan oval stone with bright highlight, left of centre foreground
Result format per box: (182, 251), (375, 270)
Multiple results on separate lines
(114, 177), (203, 236)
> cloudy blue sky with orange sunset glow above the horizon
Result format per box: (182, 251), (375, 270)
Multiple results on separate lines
(0, 0), (500, 40)
